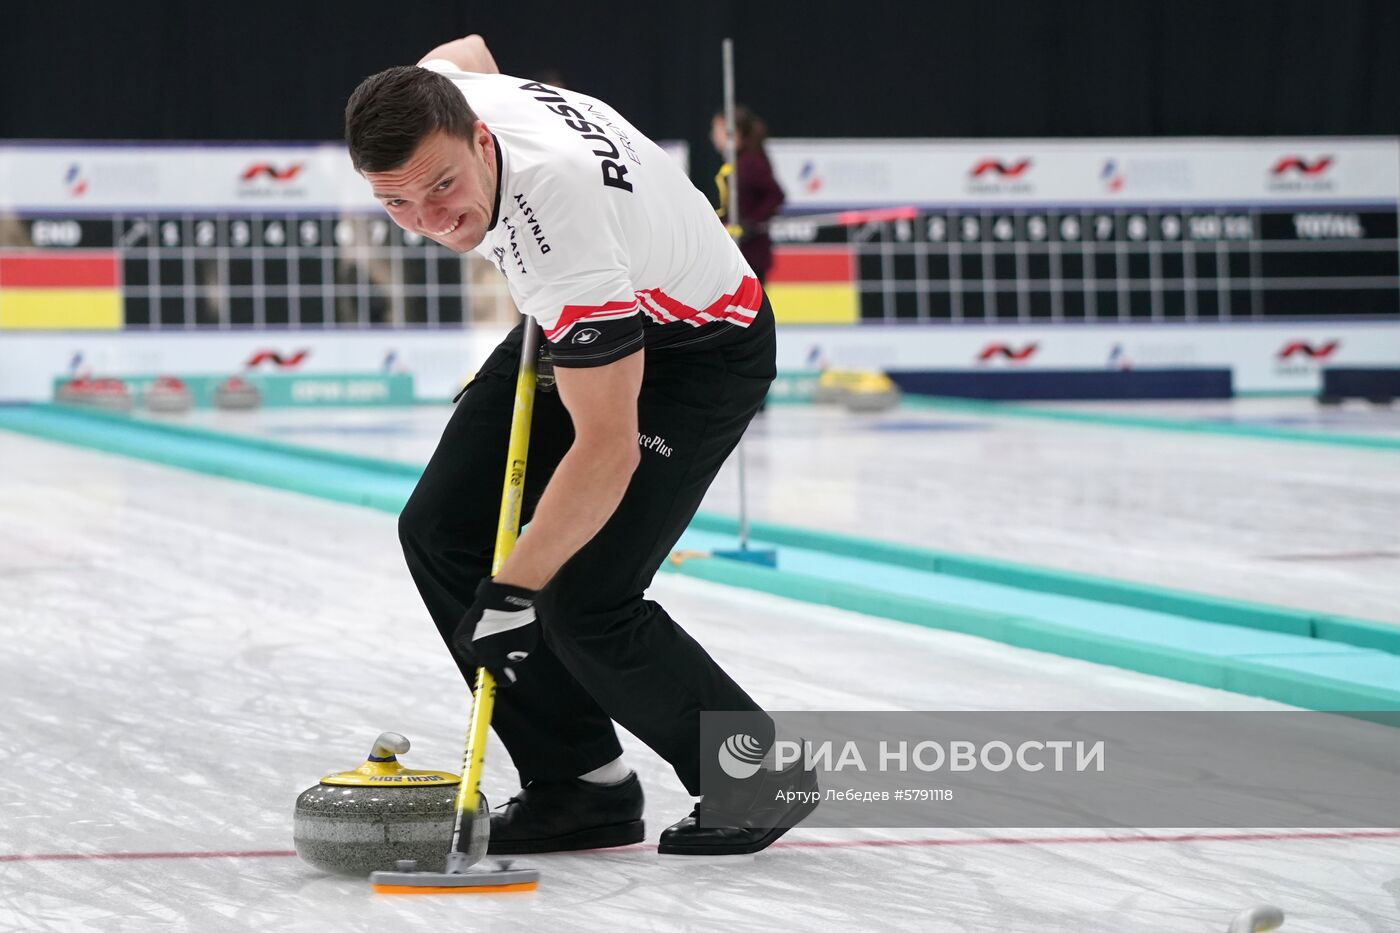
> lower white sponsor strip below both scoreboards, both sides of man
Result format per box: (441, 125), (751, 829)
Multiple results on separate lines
(0, 322), (1383, 401)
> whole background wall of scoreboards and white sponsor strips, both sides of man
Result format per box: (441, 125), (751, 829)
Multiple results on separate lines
(0, 139), (1400, 399)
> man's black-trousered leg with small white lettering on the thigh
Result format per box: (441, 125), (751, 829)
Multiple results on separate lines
(536, 298), (773, 794)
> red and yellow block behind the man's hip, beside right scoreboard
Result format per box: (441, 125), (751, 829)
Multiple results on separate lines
(763, 245), (860, 324)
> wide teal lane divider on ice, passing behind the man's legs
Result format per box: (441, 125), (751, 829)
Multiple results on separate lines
(0, 405), (1400, 712)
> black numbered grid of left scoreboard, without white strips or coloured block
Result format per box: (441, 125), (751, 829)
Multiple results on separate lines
(16, 209), (472, 329)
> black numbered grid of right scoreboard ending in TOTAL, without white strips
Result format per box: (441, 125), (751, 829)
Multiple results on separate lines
(771, 205), (1400, 324)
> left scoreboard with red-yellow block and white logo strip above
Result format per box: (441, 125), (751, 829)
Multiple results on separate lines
(0, 143), (687, 332)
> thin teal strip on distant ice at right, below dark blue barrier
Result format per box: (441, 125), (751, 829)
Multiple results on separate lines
(903, 395), (1400, 451)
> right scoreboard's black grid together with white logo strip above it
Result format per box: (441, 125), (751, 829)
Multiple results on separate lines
(770, 139), (1400, 325)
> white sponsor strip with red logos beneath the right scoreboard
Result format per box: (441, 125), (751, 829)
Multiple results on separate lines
(777, 322), (1400, 392)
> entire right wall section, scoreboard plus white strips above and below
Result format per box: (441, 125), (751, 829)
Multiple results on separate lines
(769, 139), (1400, 391)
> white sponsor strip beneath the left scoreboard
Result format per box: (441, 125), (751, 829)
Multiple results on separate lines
(0, 326), (505, 403)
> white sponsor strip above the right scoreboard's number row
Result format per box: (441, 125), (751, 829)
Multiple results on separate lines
(767, 137), (1400, 210)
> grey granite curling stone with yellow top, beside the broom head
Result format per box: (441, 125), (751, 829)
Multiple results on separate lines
(293, 733), (464, 877)
